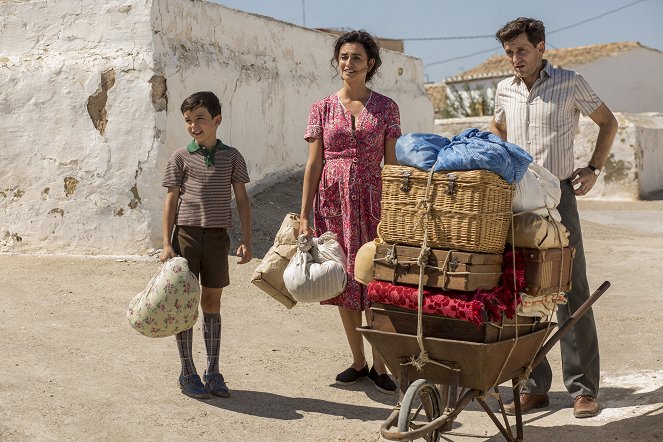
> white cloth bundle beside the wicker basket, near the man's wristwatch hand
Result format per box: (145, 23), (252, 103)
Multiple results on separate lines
(512, 163), (562, 221)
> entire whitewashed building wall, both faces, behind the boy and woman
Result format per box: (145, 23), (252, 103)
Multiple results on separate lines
(0, 0), (433, 254)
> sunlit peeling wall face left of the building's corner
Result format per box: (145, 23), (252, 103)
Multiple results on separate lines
(0, 0), (155, 254)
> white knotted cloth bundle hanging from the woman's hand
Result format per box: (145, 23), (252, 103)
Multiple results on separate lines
(283, 232), (347, 302)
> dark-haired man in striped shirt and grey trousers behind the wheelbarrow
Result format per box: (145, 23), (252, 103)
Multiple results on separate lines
(490, 17), (617, 418)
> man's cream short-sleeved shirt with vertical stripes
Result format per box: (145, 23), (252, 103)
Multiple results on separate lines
(495, 60), (603, 180)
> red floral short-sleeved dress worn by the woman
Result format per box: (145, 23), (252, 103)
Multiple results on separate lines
(304, 92), (401, 311)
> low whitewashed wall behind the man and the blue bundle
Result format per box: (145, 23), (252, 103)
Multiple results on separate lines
(435, 113), (663, 199)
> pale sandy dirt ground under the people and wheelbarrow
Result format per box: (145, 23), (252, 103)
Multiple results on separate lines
(0, 172), (663, 442)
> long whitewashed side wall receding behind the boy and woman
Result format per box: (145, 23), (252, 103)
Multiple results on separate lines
(149, 0), (433, 249)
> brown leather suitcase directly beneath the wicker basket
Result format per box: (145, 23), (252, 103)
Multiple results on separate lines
(374, 243), (502, 291)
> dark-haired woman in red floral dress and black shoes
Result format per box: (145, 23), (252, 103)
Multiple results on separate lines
(300, 31), (401, 393)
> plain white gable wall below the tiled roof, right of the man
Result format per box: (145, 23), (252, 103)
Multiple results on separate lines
(573, 48), (663, 113)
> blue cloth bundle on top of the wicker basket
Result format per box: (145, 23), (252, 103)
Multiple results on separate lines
(396, 128), (532, 184)
